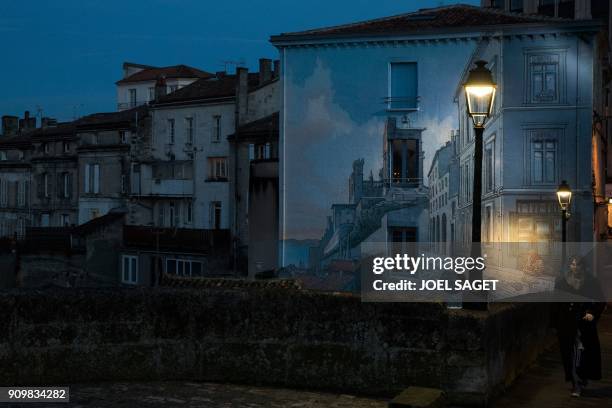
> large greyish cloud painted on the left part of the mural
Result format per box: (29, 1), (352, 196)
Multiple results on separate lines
(284, 59), (384, 239)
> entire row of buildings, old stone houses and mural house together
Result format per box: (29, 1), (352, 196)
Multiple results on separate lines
(0, 0), (612, 283)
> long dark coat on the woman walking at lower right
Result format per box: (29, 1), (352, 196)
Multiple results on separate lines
(553, 277), (606, 381)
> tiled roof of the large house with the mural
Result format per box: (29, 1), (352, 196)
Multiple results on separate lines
(271, 4), (596, 43)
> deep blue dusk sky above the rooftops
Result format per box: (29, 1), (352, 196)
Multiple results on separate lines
(0, 0), (479, 120)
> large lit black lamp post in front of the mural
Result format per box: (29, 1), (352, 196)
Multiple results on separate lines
(463, 61), (496, 310)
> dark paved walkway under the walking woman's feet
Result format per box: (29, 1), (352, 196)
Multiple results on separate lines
(493, 309), (612, 408)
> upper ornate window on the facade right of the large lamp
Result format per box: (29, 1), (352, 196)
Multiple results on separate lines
(527, 53), (560, 103)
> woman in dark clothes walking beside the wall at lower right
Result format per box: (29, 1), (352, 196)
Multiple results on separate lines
(554, 256), (606, 397)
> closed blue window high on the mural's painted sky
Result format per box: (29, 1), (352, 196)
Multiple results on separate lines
(388, 62), (417, 110)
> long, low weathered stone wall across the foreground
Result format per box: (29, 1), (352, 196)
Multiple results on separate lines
(0, 288), (546, 405)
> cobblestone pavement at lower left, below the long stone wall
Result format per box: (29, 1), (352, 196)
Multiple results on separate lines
(0, 382), (387, 408)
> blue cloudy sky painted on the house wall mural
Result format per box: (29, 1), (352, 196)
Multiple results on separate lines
(283, 42), (476, 239)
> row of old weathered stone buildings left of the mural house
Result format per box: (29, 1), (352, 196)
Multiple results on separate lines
(0, 59), (279, 285)
